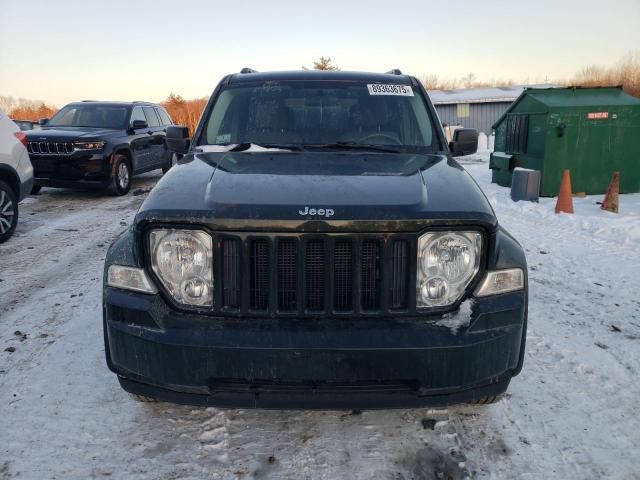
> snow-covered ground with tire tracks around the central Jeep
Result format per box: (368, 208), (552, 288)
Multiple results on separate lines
(0, 155), (640, 479)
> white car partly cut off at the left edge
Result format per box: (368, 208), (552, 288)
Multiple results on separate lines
(0, 111), (33, 243)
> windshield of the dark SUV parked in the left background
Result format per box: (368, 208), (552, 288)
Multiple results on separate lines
(47, 104), (129, 128)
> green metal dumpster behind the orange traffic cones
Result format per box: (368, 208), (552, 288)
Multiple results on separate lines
(489, 87), (640, 197)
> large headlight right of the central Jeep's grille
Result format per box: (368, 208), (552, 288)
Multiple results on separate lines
(416, 232), (482, 307)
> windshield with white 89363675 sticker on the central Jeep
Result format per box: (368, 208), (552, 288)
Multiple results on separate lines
(199, 81), (437, 151)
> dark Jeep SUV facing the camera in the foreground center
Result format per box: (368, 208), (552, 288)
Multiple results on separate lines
(103, 70), (527, 408)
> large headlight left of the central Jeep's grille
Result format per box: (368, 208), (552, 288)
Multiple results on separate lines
(149, 229), (213, 306)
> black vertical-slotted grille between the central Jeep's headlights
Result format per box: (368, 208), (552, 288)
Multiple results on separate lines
(215, 234), (415, 317)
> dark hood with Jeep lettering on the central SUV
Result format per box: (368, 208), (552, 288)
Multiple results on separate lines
(138, 152), (495, 229)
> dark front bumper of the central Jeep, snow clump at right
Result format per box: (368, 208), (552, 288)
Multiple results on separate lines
(104, 288), (527, 409)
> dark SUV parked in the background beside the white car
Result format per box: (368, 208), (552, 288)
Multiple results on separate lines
(27, 101), (174, 195)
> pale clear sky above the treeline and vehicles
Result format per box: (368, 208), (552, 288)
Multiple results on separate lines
(0, 0), (640, 106)
